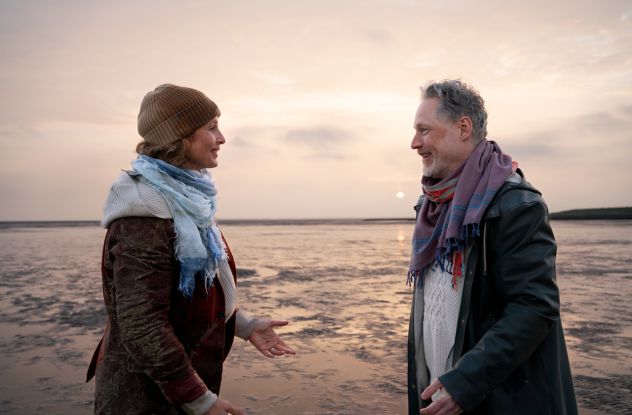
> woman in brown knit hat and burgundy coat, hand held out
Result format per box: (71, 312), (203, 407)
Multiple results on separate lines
(88, 84), (294, 415)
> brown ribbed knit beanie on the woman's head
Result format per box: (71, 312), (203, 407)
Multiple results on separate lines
(138, 84), (220, 145)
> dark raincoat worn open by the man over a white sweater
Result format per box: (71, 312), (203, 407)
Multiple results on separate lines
(408, 174), (577, 415)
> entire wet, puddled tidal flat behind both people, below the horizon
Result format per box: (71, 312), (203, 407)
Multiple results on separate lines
(0, 221), (632, 415)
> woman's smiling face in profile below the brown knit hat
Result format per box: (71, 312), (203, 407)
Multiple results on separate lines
(182, 117), (226, 170)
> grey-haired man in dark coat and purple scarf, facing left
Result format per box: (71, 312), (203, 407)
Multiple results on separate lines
(408, 81), (577, 415)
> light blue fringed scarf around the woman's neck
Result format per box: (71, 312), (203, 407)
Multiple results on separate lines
(129, 155), (226, 298)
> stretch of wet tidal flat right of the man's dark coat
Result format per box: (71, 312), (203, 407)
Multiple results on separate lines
(553, 220), (632, 414)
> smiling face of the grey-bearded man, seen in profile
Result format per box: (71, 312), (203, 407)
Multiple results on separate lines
(410, 98), (469, 179)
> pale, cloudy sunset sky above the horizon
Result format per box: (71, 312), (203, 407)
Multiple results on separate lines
(0, 0), (632, 221)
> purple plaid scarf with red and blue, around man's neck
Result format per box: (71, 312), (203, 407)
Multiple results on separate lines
(407, 140), (514, 286)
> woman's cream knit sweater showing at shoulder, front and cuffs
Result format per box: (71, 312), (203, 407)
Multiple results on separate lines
(101, 172), (257, 415)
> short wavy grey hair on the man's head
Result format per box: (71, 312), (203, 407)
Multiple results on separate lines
(421, 79), (487, 141)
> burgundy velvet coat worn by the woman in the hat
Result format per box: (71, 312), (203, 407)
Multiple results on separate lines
(88, 217), (236, 414)
